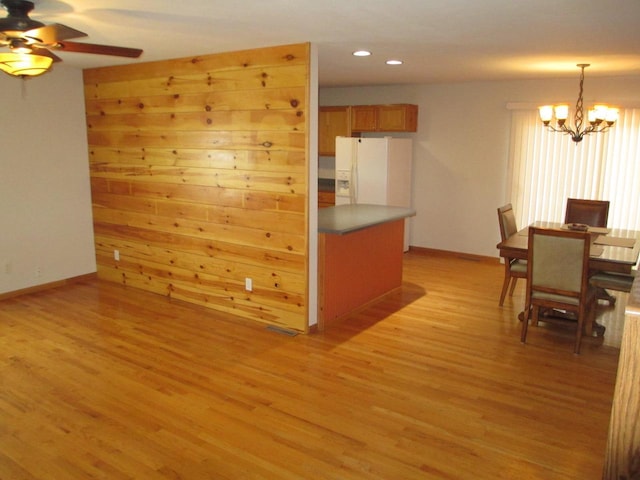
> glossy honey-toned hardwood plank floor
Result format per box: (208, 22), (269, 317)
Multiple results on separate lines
(0, 253), (624, 480)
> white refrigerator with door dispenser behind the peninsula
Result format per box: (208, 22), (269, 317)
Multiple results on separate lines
(335, 137), (413, 251)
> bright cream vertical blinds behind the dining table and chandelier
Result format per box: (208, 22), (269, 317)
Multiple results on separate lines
(508, 108), (640, 230)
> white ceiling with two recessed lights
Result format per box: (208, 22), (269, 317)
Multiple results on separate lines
(13, 0), (640, 86)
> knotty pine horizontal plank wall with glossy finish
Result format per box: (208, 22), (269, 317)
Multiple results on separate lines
(84, 44), (309, 331)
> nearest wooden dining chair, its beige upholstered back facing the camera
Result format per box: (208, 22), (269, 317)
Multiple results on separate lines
(521, 227), (596, 354)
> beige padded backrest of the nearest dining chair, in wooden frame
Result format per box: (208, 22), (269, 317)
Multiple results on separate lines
(527, 227), (591, 298)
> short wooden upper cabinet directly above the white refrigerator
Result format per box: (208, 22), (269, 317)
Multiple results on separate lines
(351, 104), (418, 132)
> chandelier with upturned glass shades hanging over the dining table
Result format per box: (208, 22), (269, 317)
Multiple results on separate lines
(539, 63), (618, 144)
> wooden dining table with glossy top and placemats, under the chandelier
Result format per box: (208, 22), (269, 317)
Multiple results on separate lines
(496, 221), (640, 336)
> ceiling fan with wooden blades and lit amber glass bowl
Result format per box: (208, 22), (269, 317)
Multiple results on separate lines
(0, 0), (142, 77)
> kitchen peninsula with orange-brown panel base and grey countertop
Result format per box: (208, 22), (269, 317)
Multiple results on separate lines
(318, 204), (416, 330)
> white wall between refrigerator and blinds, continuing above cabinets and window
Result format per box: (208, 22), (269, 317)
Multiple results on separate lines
(319, 78), (640, 257)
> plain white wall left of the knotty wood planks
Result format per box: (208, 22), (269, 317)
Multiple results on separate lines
(0, 65), (96, 293)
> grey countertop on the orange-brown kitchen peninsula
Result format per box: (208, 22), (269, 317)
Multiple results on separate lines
(318, 204), (416, 235)
